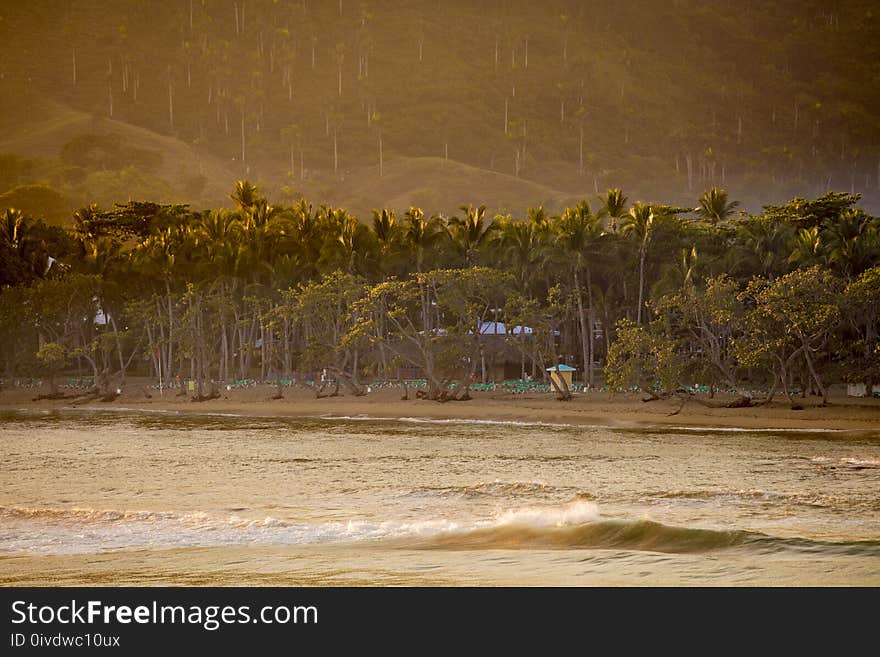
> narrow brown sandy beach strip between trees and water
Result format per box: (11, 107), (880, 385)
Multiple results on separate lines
(0, 385), (880, 435)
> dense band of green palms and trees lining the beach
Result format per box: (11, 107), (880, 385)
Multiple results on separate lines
(0, 180), (880, 400)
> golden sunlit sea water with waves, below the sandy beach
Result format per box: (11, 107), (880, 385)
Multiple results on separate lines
(0, 409), (880, 586)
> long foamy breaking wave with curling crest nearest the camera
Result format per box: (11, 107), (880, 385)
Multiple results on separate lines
(0, 496), (880, 557)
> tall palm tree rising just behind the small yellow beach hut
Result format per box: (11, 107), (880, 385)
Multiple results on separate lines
(556, 201), (604, 385)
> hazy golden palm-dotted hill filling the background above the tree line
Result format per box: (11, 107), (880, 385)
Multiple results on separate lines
(0, 0), (880, 218)
